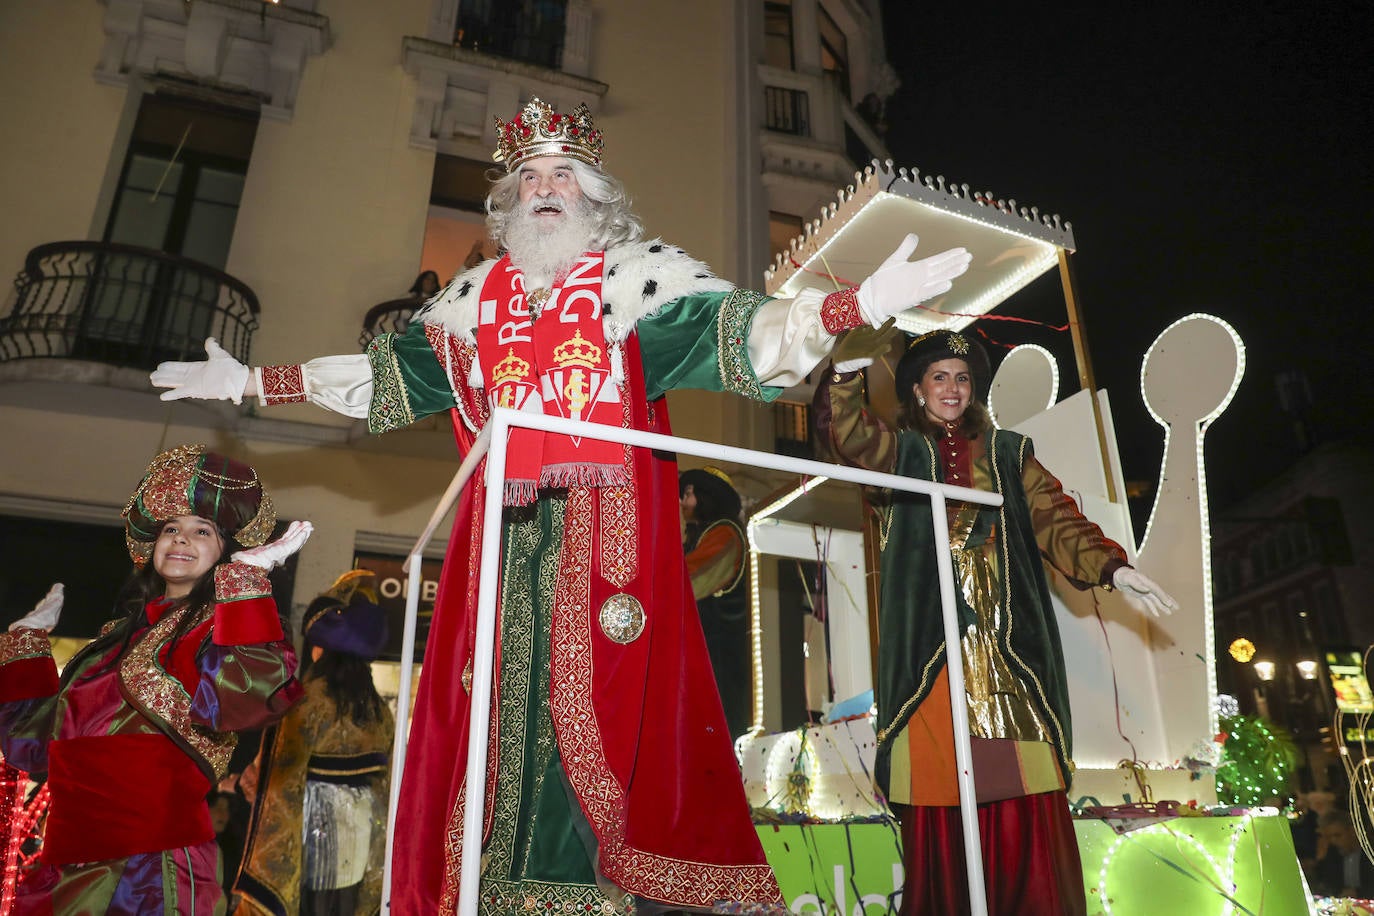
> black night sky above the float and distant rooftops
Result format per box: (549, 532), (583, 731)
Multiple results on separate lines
(886, 0), (1374, 508)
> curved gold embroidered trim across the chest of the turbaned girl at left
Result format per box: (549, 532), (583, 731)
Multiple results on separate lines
(120, 607), (239, 781)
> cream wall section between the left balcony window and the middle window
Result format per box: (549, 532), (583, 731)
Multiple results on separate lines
(225, 0), (434, 365)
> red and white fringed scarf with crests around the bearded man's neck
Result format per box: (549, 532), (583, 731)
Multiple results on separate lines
(477, 251), (625, 505)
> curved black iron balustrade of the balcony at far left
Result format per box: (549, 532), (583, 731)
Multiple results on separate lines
(0, 242), (258, 369)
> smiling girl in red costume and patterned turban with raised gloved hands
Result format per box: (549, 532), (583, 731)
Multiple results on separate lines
(0, 445), (311, 916)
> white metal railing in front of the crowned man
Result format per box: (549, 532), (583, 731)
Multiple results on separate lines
(383, 408), (1002, 916)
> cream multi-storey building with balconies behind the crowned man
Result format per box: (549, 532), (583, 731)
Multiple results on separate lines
(0, 0), (894, 730)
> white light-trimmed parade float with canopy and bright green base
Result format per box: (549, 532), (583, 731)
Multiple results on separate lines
(738, 162), (1316, 916)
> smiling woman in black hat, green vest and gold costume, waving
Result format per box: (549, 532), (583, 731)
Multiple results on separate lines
(815, 331), (1173, 916)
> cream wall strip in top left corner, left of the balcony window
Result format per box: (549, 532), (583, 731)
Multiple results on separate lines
(0, 0), (125, 281)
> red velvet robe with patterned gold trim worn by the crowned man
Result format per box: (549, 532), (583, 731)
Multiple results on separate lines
(392, 332), (782, 915)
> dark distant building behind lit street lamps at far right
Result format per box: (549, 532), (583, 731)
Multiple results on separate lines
(1212, 441), (1374, 788)
